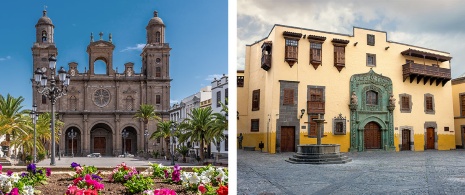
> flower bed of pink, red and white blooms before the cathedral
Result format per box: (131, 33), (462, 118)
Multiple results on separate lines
(31, 163), (228, 195)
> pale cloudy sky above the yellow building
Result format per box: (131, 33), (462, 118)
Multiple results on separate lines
(237, 0), (465, 77)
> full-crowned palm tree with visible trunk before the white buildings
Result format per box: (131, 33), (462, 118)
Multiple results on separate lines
(180, 107), (215, 163)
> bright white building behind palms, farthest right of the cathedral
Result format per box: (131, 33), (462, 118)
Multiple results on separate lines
(211, 74), (228, 156)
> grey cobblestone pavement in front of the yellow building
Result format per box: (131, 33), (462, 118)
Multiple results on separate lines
(237, 150), (465, 195)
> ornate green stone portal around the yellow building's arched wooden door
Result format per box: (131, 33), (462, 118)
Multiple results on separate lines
(349, 69), (395, 152)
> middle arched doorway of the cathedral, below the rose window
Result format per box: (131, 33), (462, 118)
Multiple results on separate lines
(90, 122), (114, 156)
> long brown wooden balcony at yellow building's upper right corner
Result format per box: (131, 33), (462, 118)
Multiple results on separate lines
(402, 63), (451, 86)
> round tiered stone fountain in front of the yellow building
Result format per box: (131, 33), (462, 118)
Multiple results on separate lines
(286, 114), (352, 164)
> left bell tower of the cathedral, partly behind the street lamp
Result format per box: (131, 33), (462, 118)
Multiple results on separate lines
(31, 10), (58, 112)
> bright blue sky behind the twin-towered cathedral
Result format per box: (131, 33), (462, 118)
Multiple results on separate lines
(0, 0), (228, 108)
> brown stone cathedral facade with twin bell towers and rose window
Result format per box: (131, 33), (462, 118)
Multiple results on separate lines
(32, 11), (172, 156)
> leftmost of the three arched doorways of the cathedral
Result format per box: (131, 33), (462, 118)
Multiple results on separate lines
(62, 125), (82, 156)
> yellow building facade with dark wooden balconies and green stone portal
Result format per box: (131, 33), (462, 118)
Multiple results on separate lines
(237, 25), (454, 153)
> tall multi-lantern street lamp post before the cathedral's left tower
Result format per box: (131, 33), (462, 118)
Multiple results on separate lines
(34, 55), (70, 166)
